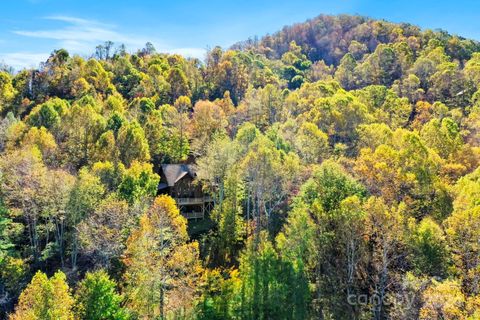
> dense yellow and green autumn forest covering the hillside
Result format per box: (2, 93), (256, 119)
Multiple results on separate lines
(0, 15), (480, 320)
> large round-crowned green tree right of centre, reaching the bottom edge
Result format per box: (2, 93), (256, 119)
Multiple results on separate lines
(284, 161), (367, 317)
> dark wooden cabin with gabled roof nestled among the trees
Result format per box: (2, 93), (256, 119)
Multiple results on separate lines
(158, 164), (213, 220)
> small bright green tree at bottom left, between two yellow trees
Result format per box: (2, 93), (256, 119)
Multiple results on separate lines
(75, 270), (129, 320)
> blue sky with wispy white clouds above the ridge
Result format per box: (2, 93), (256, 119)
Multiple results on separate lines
(0, 0), (480, 69)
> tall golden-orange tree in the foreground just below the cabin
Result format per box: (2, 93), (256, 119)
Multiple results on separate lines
(124, 196), (200, 319)
